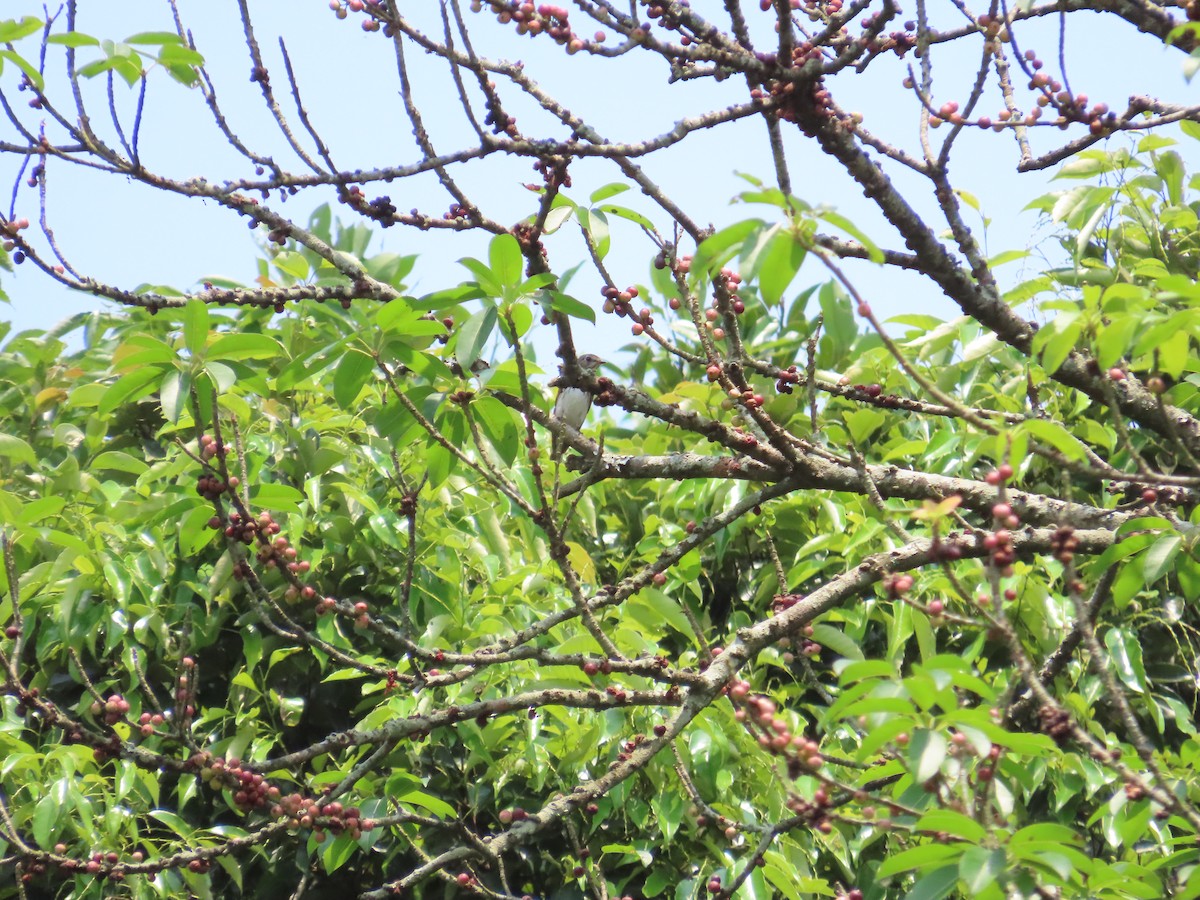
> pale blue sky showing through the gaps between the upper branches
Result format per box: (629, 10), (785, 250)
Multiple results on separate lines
(0, 0), (1198, 362)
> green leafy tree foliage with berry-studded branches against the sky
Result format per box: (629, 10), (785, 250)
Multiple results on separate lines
(0, 0), (1200, 900)
